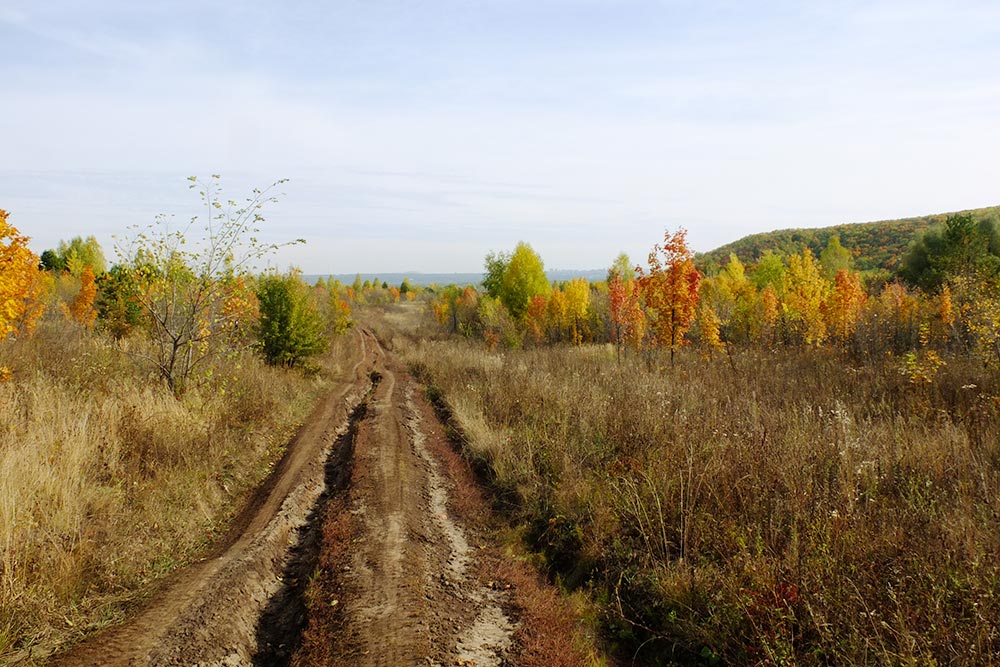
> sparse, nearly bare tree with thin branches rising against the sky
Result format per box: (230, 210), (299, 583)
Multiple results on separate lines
(118, 175), (302, 395)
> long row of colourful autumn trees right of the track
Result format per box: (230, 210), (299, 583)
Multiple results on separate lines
(432, 213), (1000, 381)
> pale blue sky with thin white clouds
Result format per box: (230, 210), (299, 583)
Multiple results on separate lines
(0, 0), (1000, 274)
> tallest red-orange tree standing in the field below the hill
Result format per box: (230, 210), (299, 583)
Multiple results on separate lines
(638, 229), (701, 363)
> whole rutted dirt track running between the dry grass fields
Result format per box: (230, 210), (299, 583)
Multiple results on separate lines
(52, 330), (515, 667)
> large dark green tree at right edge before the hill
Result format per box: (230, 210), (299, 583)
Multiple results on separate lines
(899, 213), (1000, 292)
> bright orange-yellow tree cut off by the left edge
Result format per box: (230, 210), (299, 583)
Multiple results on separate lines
(0, 209), (44, 340)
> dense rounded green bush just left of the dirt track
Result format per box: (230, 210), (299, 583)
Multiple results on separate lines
(257, 271), (328, 366)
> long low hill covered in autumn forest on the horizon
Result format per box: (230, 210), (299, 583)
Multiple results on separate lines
(695, 206), (1000, 271)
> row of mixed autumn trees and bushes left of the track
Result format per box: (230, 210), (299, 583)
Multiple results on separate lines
(0, 176), (351, 395)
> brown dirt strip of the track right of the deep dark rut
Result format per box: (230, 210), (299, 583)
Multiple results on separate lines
(286, 342), (514, 667)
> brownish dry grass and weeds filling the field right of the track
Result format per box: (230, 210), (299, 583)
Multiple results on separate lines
(394, 312), (1000, 665)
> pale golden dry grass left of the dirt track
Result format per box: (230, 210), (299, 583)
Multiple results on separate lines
(0, 318), (356, 664)
